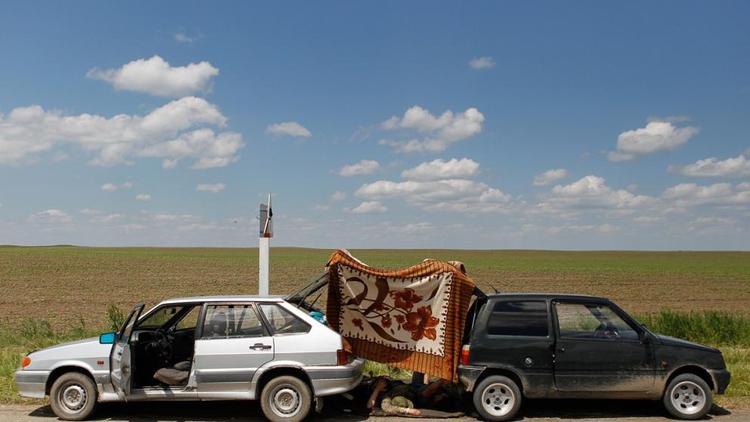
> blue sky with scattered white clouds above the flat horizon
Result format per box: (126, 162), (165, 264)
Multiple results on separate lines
(0, 1), (750, 249)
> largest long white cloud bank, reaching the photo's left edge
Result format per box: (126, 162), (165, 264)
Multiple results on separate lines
(0, 97), (243, 169)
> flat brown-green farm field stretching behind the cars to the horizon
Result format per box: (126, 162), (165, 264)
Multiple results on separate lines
(0, 247), (750, 328)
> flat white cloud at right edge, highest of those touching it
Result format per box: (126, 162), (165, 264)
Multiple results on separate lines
(662, 183), (750, 207)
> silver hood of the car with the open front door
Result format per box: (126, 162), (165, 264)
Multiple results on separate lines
(26, 337), (112, 370)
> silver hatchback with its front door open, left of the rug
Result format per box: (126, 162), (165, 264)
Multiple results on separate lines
(15, 296), (364, 421)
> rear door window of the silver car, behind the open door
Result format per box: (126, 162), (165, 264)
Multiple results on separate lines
(201, 304), (266, 338)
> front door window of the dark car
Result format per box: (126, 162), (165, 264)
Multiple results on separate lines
(555, 302), (638, 340)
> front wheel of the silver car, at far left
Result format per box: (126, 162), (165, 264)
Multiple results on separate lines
(49, 372), (96, 421)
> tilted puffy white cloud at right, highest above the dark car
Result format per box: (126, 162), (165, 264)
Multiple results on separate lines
(607, 120), (698, 161)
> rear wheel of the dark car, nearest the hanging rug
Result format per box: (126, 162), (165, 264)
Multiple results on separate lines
(473, 375), (522, 421)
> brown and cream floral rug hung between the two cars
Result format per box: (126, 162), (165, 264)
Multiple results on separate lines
(327, 250), (475, 381)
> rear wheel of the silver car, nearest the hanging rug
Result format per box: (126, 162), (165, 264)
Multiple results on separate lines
(260, 375), (313, 422)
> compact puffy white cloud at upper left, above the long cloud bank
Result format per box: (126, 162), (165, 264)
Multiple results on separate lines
(86, 56), (219, 97)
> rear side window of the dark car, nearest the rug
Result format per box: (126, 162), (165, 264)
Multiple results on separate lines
(487, 300), (549, 337)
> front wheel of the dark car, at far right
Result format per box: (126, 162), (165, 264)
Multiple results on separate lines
(662, 374), (713, 420)
